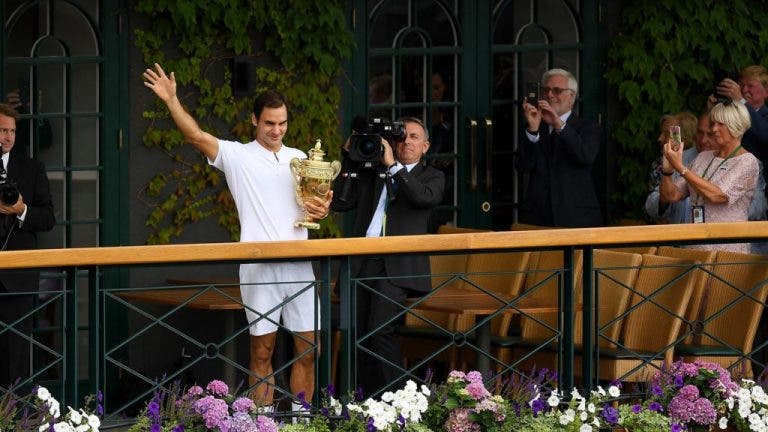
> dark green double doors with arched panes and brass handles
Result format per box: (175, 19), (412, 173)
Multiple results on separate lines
(350, 0), (602, 230)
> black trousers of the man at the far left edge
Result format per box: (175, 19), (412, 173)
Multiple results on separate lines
(0, 287), (34, 388)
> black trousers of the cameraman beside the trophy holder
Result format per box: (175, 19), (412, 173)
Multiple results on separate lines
(355, 259), (408, 397)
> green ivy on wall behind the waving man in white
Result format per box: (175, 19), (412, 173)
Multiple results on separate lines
(135, 0), (353, 244)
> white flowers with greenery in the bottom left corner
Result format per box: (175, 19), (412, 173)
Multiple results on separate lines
(0, 387), (103, 432)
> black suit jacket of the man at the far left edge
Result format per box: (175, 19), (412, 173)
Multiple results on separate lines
(0, 152), (56, 292)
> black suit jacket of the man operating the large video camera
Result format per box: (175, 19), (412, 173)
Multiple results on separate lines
(331, 157), (445, 292)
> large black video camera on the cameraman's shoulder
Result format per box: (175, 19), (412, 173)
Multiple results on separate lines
(349, 118), (405, 168)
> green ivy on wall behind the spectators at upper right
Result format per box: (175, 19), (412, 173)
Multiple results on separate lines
(606, 0), (768, 218)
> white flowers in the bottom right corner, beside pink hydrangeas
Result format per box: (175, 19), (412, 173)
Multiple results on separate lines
(726, 379), (768, 432)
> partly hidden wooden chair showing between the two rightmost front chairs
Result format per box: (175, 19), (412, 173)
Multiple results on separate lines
(656, 246), (717, 344)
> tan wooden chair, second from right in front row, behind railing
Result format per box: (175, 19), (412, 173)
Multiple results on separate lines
(575, 254), (695, 382)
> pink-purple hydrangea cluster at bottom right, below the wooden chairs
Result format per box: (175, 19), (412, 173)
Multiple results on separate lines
(648, 360), (739, 432)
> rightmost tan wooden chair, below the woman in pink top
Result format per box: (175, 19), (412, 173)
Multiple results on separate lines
(677, 251), (768, 376)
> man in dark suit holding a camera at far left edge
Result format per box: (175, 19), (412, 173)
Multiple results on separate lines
(0, 104), (56, 386)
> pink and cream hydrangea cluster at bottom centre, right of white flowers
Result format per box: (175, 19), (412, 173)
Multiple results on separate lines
(424, 371), (510, 432)
